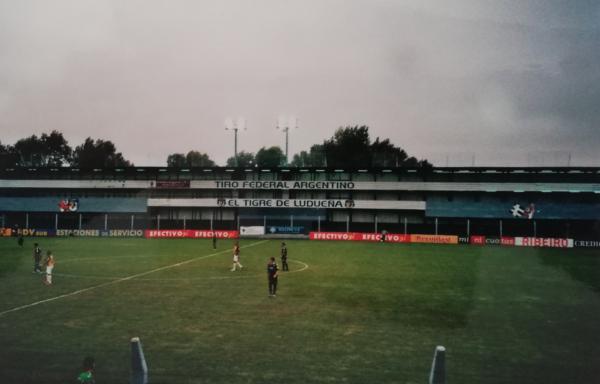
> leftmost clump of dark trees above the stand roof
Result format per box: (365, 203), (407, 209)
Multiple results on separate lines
(0, 131), (133, 168)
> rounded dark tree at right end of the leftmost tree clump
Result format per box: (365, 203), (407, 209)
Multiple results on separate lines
(71, 137), (133, 168)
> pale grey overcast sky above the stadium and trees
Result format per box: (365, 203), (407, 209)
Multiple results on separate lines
(0, 0), (600, 166)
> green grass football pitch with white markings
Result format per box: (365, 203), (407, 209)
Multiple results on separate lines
(0, 238), (600, 384)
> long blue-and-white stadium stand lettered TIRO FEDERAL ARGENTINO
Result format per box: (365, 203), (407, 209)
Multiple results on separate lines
(0, 167), (600, 242)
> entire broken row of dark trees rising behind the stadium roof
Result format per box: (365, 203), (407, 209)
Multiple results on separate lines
(0, 126), (431, 168)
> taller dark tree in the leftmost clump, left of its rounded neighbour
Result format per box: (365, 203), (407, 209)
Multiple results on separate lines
(13, 131), (72, 167)
